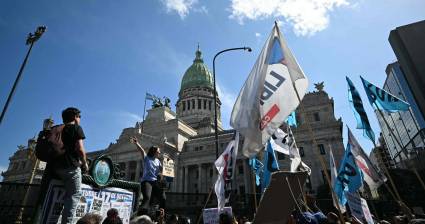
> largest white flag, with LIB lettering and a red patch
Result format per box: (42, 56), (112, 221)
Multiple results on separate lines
(230, 21), (308, 157)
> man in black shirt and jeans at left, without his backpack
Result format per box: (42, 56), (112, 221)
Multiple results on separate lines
(54, 107), (88, 224)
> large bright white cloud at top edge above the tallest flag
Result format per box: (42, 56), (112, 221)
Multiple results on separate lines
(230, 0), (350, 36)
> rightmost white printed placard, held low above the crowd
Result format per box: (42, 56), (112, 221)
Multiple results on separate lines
(346, 192), (374, 224)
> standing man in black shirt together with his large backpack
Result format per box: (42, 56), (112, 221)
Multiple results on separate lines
(36, 107), (88, 224)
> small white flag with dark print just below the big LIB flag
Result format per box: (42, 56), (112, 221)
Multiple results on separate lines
(270, 125), (311, 175)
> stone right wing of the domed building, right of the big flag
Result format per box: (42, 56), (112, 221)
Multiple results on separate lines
(278, 88), (344, 194)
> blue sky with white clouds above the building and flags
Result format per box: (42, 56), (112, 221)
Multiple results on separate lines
(0, 0), (425, 178)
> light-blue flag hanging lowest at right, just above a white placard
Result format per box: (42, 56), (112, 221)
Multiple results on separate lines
(334, 138), (363, 205)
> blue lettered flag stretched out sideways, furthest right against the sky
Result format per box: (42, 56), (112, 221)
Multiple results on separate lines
(360, 76), (410, 112)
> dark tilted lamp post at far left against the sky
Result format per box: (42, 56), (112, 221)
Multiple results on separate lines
(0, 26), (46, 124)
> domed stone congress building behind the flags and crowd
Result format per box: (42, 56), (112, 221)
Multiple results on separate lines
(3, 49), (344, 201)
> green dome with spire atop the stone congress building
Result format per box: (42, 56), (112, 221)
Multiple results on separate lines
(180, 46), (213, 92)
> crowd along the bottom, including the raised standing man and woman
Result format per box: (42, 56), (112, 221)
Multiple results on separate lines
(37, 107), (425, 224)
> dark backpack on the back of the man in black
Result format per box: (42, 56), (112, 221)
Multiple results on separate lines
(35, 124), (66, 162)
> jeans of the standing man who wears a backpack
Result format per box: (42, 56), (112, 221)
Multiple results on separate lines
(55, 167), (82, 224)
